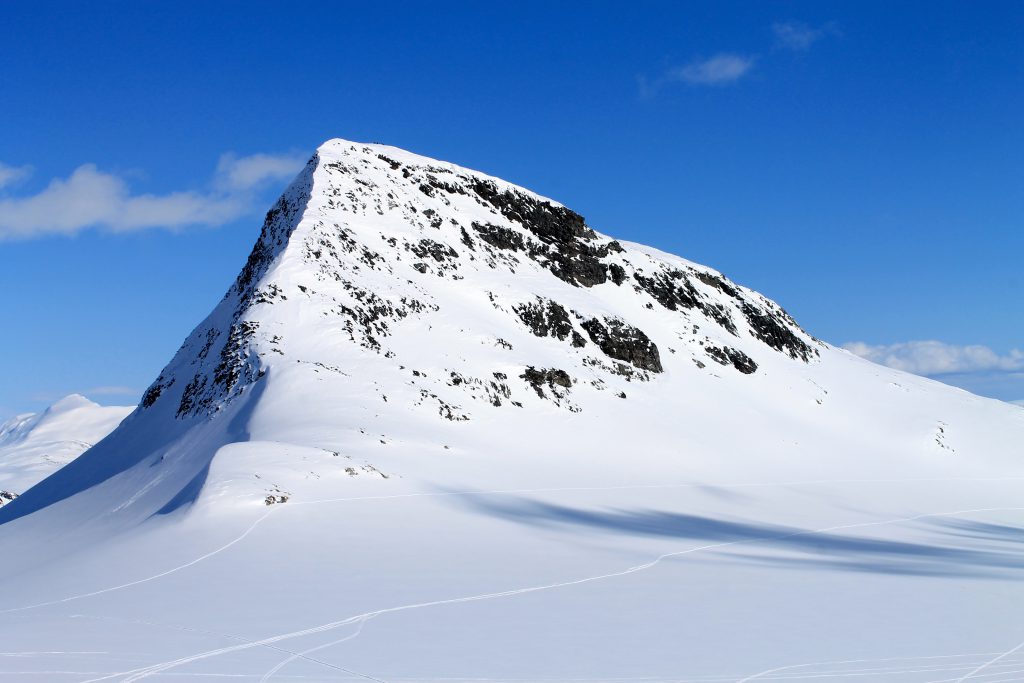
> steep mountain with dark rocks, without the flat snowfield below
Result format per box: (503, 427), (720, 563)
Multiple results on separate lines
(6, 140), (1014, 524)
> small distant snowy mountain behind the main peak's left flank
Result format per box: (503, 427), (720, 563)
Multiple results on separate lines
(0, 394), (133, 505)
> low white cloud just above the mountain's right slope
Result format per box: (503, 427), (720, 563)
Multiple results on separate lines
(843, 341), (1024, 375)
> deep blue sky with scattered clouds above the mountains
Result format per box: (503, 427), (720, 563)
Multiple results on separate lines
(0, 1), (1024, 416)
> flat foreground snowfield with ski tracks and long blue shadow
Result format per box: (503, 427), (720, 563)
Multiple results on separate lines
(3, 479), (1024, 681)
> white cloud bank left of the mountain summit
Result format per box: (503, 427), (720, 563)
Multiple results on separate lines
(0, 155), (305, 240)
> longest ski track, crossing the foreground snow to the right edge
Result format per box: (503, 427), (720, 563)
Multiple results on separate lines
(75, 501), (1024, 683)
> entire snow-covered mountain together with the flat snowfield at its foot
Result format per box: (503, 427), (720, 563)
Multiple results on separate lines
(0, 140), (1024, 681)
